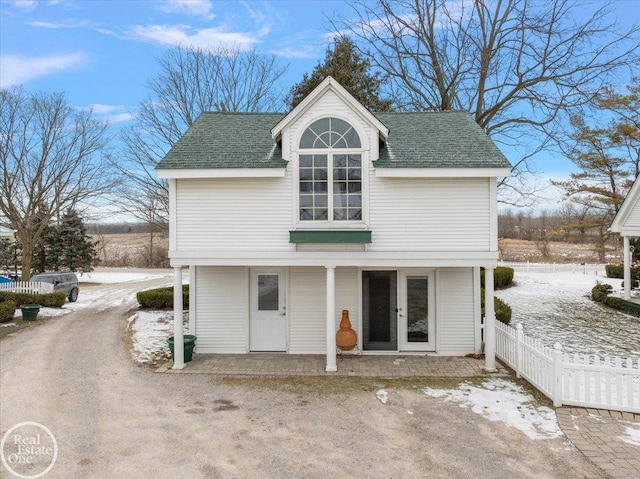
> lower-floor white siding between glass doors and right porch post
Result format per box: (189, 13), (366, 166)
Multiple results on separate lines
(436, 268), (475, 355)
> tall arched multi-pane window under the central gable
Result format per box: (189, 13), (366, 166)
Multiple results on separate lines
(299, 118), (362, 222)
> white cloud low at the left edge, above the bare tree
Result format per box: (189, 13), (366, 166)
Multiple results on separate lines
(0, 52), (87, 88)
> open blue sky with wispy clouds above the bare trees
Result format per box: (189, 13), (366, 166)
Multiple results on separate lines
(0, 0), (640, 209)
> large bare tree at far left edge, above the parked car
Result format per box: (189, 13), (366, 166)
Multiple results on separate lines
(0, 87), (110, 280)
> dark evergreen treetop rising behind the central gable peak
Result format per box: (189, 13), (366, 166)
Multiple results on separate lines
(286, 36), (391, 112)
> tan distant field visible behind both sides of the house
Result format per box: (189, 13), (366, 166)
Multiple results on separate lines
(93, 233), (622, 267)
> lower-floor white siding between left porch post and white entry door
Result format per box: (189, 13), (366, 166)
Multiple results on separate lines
(195, 266), (249, 353)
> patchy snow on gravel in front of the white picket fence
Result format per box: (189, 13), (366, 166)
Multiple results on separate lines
(424, 379), (563, 439)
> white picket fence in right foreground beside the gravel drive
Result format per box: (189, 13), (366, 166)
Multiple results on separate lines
(496, 321), (640, 413)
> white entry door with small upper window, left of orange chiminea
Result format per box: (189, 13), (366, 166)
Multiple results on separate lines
(249, 269), (287, 351)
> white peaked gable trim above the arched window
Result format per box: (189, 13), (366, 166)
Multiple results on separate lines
(271, 76), (389, 140)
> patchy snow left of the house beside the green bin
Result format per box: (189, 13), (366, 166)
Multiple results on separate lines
(129, 311), (189, 364)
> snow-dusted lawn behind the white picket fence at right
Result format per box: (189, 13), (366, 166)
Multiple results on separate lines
(496, 268), (640, 359)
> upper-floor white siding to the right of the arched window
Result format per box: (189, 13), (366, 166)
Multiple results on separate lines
(367, 176), (491, 251)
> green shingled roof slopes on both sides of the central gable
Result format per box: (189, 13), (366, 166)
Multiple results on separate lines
(157, 111), (511, 169)
